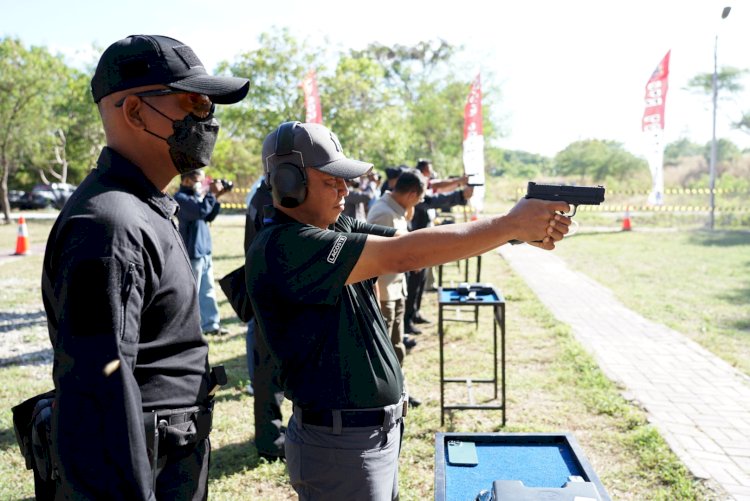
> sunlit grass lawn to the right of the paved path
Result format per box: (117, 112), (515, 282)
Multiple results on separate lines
(555, 229), (750, 374)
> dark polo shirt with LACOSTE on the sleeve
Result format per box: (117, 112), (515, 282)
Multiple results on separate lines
(246, 211), (403, 410)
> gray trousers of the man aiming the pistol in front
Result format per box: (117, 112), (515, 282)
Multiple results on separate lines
(284, 398), (404, 501)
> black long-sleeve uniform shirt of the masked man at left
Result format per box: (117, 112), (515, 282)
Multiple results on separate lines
(42, 148), (209, 500)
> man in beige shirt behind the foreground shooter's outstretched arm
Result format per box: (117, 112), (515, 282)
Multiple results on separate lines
(367, 169), (427, 407)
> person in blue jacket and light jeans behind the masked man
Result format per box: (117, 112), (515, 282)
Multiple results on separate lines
(174, 169), (229, 336)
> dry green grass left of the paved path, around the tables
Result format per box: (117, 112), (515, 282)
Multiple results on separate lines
(0, 217), (718, 501)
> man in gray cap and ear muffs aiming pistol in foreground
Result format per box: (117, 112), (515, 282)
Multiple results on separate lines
(246, 122), (570, 500)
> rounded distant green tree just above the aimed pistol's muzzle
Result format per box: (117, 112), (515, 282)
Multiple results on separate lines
(554, 139), (648, 182)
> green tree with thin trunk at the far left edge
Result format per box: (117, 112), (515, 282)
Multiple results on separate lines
(0, 38), (66, 224)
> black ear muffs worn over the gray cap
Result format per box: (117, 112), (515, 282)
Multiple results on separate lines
(269, 122), (307, 209)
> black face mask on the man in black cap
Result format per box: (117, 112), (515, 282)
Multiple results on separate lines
(143, 101), (219, 174)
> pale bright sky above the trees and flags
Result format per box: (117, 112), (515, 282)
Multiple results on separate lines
(0, 0), (750, 156)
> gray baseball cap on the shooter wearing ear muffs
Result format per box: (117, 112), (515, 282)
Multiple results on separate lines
(263, 122), (372, 179)
